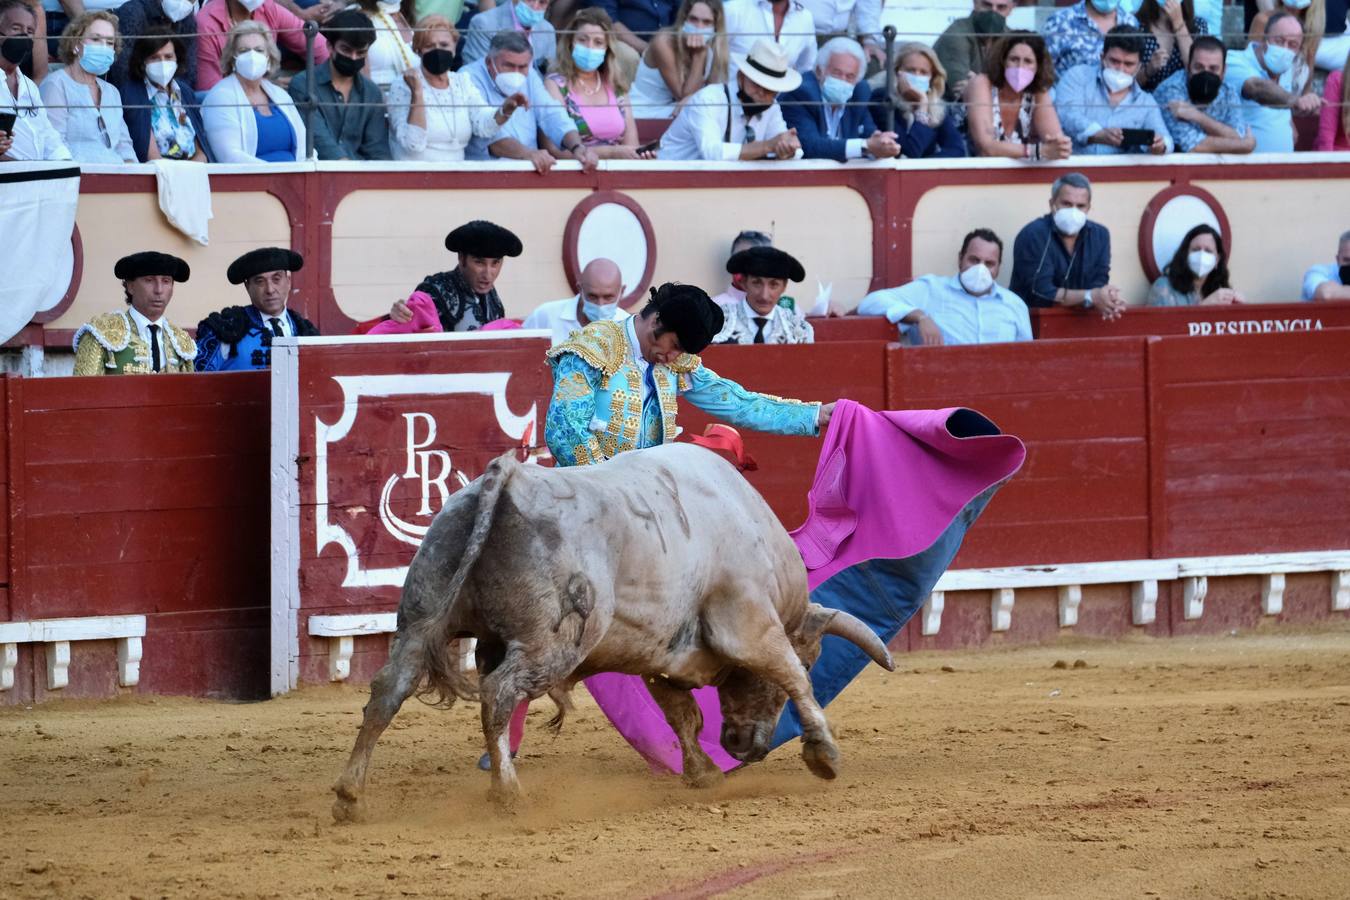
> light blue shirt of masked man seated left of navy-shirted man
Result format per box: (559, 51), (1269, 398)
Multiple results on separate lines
(857, 275), (1031, 344)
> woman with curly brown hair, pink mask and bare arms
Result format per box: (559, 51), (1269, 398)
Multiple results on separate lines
(965, 31), (1073, 159)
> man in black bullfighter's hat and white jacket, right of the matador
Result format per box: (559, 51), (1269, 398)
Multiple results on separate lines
(713, 247), (815, 344)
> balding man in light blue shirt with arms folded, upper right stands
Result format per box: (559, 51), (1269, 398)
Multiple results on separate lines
(1224, 12), (1322, 152)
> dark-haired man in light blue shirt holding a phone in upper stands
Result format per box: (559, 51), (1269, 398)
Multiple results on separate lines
(1054, 26), (1172, 155)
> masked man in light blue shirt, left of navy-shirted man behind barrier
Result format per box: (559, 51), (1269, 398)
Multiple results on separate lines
(857, 228), (1031, 345)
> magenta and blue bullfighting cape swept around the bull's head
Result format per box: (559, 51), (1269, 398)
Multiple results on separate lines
(586, 399), (1026, 772)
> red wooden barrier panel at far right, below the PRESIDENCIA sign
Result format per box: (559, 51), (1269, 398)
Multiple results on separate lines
(1149, 329), (1350, 557)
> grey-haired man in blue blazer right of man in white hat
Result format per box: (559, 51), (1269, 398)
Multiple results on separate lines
(779, 38), (900, 162)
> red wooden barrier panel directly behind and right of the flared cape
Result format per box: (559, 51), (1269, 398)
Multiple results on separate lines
(887, 337), (1149, 568)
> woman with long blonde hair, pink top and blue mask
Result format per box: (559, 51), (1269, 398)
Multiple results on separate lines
(545, 7), (653, 159)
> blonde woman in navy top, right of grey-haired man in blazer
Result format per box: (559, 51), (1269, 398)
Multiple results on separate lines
(872, 40), (965, 159)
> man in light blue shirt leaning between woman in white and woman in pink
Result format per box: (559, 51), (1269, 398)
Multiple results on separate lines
(464, 31), (599, 174)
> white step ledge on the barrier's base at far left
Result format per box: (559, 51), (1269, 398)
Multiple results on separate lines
(0, 615), (146, 691)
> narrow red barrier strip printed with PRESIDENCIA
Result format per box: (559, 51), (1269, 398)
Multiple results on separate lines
(1031, 302), (1350, 339)
